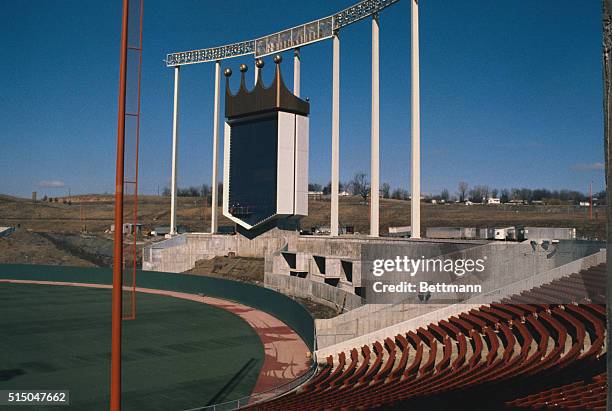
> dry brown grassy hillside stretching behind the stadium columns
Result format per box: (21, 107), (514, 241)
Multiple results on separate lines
(0, 194), (606, 238)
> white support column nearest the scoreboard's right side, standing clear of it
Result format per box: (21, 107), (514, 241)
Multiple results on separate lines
(330, 32), (340, 236)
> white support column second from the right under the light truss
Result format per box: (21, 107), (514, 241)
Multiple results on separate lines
(370, 15), (380, 237)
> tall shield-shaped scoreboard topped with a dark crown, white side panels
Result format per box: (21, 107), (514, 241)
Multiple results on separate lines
(223, 56), (310, 230)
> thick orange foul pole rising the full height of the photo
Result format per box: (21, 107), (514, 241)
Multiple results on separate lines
(110, 0), (129, 411)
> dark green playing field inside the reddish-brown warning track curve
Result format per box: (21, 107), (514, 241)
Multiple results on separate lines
(0, 283), (264, 410)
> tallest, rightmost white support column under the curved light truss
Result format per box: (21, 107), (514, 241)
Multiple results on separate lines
(410, 0), (421, 238)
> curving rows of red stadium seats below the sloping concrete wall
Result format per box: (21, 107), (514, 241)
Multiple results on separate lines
(247, 266), (606, 410)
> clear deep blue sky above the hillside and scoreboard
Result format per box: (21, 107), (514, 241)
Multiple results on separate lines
(0, 0), (604, 200)
